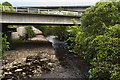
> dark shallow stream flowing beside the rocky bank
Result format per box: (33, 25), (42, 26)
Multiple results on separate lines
(46, 35), (89, 79)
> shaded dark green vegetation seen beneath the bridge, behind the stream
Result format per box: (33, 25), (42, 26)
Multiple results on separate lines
(35, 25), (68, 40)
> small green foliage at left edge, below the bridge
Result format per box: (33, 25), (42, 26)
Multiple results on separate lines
(0, 33), (10, 59)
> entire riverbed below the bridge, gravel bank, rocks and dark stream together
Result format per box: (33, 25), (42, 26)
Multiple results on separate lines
(2, 27), (89, 80)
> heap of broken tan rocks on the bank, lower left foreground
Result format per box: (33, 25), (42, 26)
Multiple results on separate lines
(2, 53), (58, 79)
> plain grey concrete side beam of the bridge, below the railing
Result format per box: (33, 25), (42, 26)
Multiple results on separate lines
(0, 11), (81, 25)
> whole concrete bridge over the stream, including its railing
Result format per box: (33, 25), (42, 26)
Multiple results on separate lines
(0, 6), (88, 29)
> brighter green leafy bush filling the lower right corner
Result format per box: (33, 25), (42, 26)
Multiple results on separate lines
(88, 25), (120, 80)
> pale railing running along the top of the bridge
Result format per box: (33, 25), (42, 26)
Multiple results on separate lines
(0, 6), (84, 16)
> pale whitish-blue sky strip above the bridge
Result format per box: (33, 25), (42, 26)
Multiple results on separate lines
(0, 0), (100, 6)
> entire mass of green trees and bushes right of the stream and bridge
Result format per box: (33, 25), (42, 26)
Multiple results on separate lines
(68, 2), (120, 80)
